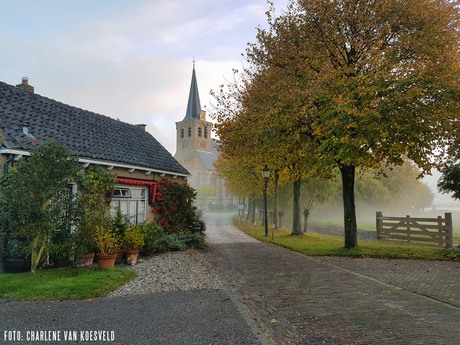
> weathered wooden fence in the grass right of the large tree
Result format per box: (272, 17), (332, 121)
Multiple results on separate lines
(376, 212), (453, 248)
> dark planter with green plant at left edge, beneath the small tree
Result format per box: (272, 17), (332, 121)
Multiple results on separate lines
(3, 239), (32, 273)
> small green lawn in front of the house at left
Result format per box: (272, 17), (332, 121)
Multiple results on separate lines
(0, 267), (137, 301)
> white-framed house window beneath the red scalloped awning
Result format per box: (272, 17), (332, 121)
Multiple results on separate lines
(110, 187), (148, 224)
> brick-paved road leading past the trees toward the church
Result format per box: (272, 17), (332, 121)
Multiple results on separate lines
(205, 214), (460, 345)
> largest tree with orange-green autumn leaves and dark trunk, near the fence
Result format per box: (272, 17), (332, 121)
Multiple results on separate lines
(234, 0), (460, 248)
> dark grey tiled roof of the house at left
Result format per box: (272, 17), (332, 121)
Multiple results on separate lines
(0, 82), (189, 174)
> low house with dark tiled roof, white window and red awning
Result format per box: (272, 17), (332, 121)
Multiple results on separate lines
(0, 78), (190, 223)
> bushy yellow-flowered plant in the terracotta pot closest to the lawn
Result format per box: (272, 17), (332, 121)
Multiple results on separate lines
(94, 226), (119, 269)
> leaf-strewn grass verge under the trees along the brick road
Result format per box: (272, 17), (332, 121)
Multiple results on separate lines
(233, 218), (460, 260)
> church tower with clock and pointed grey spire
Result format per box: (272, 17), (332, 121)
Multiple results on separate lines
(174, 63), (212, 184)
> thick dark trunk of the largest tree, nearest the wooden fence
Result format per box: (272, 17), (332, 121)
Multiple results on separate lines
(340, 165), (358, 248)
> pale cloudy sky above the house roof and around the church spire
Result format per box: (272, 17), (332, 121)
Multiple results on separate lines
(0, 0), (287, 150)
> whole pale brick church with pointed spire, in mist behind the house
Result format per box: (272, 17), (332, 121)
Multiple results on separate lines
(174, 64), (236, 211)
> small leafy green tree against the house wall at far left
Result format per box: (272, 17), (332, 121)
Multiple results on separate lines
(0, 141), (80, 270)
